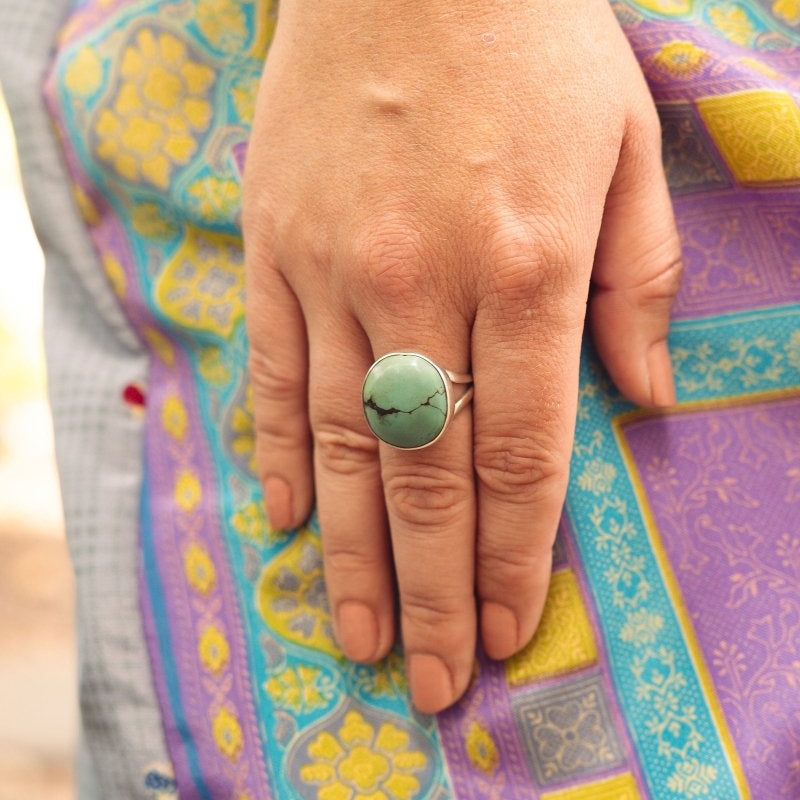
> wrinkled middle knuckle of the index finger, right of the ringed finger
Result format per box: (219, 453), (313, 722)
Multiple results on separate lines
(475, 435), (569, 504)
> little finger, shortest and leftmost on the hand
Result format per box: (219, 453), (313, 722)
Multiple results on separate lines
(245, 240), (313, 529)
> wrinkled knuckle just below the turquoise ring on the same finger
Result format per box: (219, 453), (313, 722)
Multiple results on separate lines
(384, 465), (471, 529)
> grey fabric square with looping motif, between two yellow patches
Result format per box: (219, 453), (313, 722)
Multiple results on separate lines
(512, 675), (625, 786)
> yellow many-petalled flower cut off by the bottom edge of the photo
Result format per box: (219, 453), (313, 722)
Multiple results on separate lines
(300, 711), (428, 800)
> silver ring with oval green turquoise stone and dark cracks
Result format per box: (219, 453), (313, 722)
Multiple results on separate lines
(361, 352), (473, 450)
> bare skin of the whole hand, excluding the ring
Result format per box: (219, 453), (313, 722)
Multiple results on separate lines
(243, 0), (680, 712)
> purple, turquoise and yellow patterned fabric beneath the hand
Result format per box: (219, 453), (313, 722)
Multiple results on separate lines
(40, 0), (800, 800)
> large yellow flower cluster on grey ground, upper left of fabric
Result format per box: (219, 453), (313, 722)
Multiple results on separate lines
(94, 28), (214, 189)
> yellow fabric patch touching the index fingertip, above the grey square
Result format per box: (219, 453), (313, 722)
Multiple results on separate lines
(506, 569), (597, 686)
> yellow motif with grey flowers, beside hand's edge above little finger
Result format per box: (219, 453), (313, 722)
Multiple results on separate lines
(154, 226), (244, 339)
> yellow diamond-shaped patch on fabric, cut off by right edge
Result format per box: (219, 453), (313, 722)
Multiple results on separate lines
(697, 89), (800, 184)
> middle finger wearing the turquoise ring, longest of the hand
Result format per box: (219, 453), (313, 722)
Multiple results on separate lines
(374, 340), (476, 713)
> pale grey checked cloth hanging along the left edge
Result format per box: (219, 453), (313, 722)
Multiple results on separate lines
(0, 0), (170, 800)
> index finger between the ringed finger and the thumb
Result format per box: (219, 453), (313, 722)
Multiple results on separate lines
(472, 222), (591, 659)
